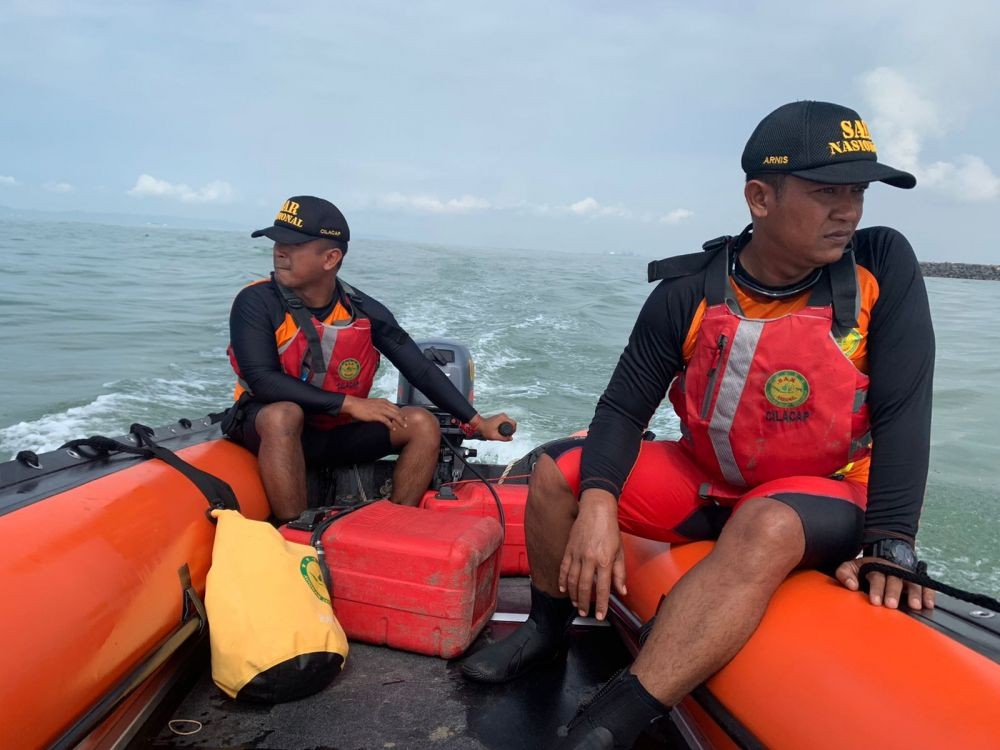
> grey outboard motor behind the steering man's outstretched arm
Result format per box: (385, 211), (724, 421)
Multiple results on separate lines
(396, 339), (476, 490)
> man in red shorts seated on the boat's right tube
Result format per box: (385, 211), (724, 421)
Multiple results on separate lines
(462, 101), (934, 749)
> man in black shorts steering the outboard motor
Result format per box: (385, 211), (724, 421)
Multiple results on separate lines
(223, 195), (516, 521)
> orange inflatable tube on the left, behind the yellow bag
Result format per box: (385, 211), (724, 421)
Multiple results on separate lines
(0, 418), (267, 748)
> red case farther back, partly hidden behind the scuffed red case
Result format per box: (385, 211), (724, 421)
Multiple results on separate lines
(420, 480), (529, 576)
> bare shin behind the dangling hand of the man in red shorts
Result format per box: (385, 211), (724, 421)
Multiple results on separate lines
(524, 454), (580, 598)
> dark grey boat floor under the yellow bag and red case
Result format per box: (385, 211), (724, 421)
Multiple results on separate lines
(141, 578), (685, 750)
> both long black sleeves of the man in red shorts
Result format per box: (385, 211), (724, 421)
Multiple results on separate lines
(580, 227), (934, 543)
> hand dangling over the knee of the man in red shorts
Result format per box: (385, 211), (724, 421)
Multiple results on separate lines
(559, 490), (625, 620)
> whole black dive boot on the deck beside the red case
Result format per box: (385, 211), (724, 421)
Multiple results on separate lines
(462, 586), (576, 682)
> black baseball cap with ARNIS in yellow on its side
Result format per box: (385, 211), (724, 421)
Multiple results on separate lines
(743, 101), (917, 188)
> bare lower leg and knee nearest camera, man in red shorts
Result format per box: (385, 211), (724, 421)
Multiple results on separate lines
(631, 498), (805, 706)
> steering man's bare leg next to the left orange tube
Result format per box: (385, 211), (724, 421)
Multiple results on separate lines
(254, 401), (306, 521)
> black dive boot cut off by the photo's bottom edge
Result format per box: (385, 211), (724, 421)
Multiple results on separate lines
(556, 667), (670, 750)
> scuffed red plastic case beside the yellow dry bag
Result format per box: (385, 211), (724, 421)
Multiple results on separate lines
(281, 500), (501, 659)
